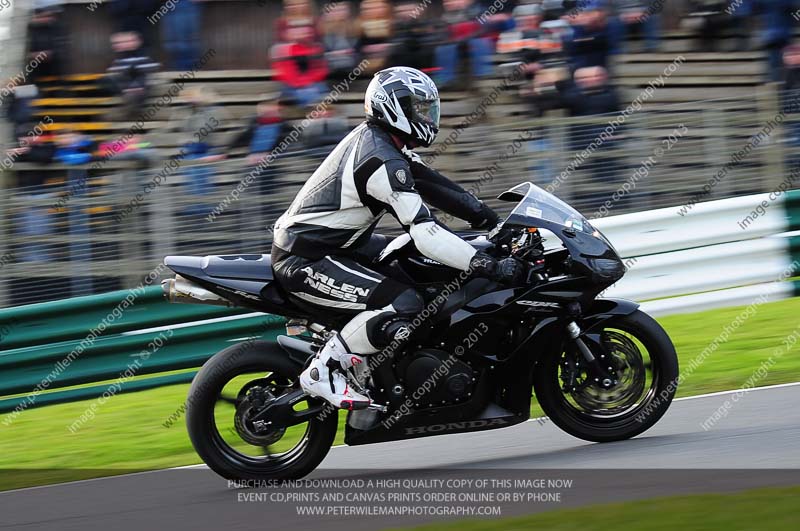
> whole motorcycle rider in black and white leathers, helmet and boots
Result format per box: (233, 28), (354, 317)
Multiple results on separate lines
(272, 67), (522, 409)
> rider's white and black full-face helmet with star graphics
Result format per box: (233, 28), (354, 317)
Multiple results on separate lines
(364, 66), (439, 147)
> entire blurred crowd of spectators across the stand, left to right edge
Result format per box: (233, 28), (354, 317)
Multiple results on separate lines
(4, 0), (800, 179)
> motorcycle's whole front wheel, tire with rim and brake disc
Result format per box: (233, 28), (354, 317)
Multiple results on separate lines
(533, 310), (678, 442)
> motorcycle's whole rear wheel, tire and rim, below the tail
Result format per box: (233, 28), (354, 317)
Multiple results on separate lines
(186, 341), (338, 480)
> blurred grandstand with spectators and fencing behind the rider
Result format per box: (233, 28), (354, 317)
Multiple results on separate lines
(0, 0), (800, 307)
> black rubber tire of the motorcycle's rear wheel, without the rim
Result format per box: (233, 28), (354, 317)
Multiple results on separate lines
(186, 341), (338, 480)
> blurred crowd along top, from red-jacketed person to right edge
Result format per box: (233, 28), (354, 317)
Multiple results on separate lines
(271, 0), (800, 109)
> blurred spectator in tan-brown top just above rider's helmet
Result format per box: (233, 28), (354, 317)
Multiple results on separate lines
(356, 0), (393, 74)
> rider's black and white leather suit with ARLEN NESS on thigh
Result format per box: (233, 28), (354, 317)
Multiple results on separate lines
(272, 122), (499, 354)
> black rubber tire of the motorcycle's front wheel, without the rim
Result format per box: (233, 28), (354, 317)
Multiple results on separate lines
(533, 310), (678, 442)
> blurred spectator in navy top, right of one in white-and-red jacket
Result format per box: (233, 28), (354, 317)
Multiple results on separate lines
(565, 0), (613, 71)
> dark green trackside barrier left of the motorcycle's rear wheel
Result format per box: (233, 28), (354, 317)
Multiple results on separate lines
(0, 287), (284, 412)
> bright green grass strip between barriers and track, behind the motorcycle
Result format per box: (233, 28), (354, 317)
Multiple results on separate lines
(0, 298), (800, 490)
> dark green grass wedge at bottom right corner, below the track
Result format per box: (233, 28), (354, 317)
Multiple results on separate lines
(396, 487), (800, 531)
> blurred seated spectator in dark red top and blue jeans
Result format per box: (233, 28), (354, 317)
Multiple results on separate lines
(436, 0), (494, 89)
